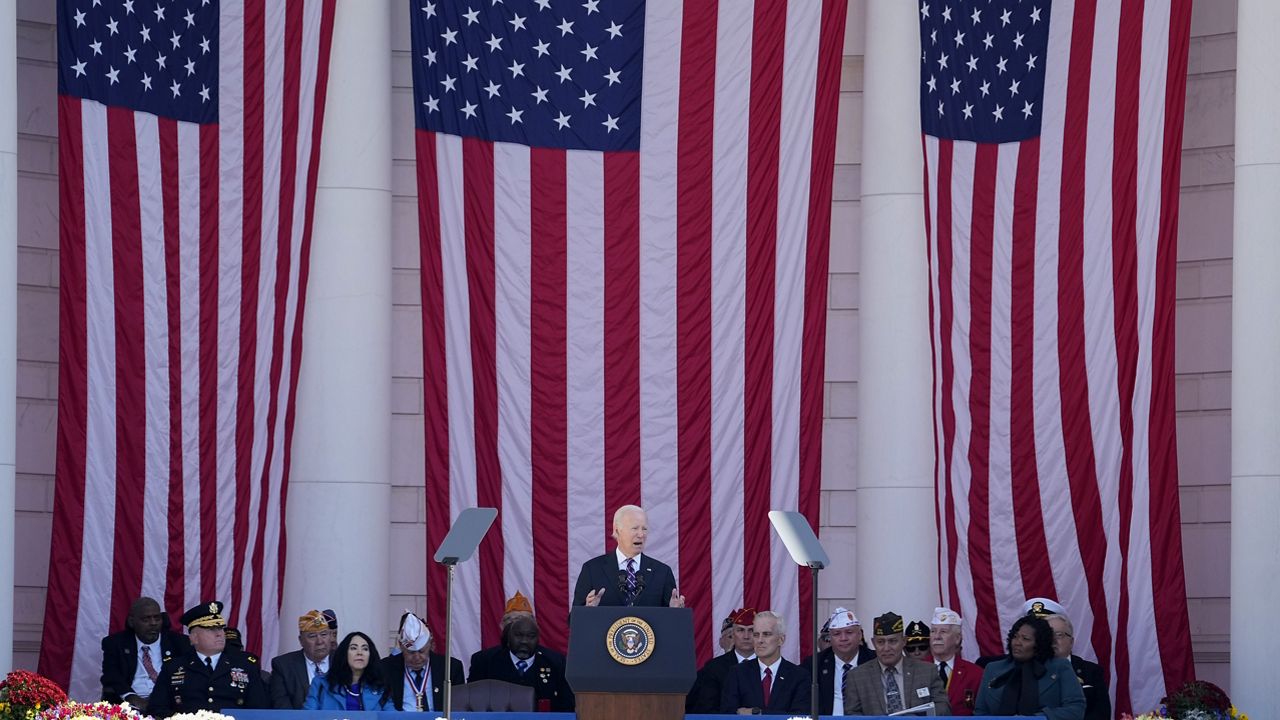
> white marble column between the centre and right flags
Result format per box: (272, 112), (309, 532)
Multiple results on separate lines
(855, 0), (938, 623)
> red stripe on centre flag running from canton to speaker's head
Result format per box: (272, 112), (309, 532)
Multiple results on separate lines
(604, 152), (640, 546)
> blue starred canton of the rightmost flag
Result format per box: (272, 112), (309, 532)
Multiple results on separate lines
(919, 0), (1050, 142)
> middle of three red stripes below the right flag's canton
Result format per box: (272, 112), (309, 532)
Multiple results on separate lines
(957, 143), (1000, 655)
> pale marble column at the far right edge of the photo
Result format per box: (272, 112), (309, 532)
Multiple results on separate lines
(1230, 0), (1280, 717)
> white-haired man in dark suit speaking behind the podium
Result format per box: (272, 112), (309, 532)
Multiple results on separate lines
(573, 505), (685, 607)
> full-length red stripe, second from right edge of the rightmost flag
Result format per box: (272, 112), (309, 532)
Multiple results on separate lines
(1103, 3), (1143, 712)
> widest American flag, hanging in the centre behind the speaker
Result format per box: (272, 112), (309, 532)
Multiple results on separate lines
(410, 0), (846, 657)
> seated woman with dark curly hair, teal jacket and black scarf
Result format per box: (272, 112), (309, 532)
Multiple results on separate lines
(973, 615), (1084, 720)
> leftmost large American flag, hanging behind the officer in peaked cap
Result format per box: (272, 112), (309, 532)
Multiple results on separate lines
(40, 0), (333, 698)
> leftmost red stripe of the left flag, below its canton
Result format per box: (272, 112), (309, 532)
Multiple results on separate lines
(38, 95), (88, 688)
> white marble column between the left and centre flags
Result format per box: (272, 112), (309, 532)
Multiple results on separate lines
(280, 0), (391, 651)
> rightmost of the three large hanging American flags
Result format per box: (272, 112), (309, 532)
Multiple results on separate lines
(918, 0), (1193, 711)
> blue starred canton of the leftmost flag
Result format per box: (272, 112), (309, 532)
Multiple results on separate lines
(58, 0), (219, 123)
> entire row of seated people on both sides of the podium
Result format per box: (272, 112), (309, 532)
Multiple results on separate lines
(102, 592), (1111, 720)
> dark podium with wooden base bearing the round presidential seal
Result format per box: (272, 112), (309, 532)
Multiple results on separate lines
(564, 607), (698, 720)
